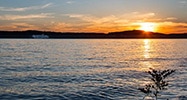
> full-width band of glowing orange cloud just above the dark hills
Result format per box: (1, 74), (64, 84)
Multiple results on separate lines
(0, 12), (187, 33)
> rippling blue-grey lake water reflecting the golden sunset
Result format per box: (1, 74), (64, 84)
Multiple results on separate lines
(0, 39), (187, 100)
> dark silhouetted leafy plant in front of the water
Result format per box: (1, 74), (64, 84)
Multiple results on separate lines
(138, 69), (175, 100)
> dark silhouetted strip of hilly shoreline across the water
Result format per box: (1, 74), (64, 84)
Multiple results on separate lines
(0, 30), (187, 39)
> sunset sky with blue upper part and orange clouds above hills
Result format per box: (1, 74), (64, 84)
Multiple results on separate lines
(0, 0), (187, 33)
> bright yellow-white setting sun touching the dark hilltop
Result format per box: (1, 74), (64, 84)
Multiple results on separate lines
(139, 22), (156, 32)
